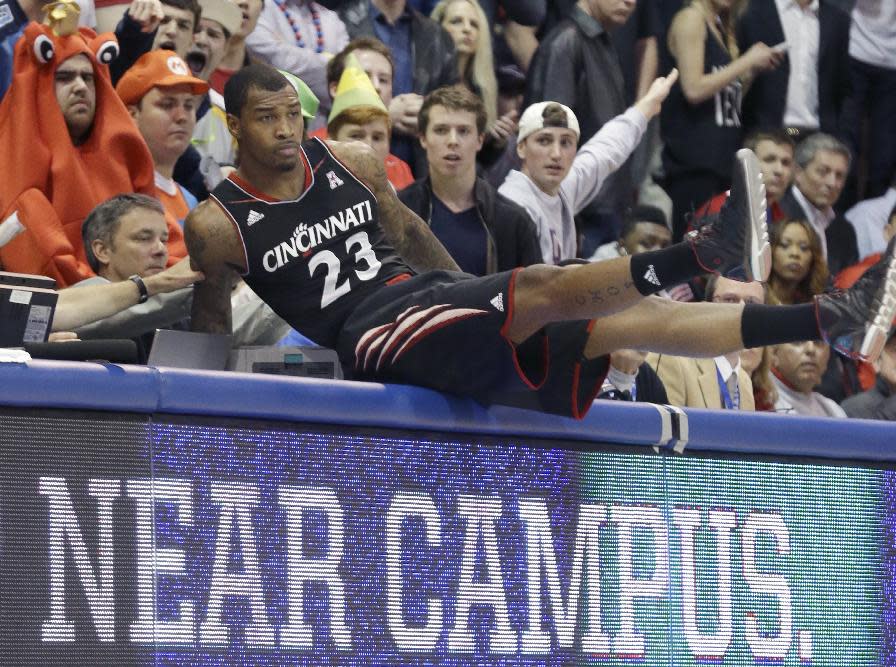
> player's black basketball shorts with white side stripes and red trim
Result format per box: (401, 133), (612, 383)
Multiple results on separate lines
(337, 269), (609, 419)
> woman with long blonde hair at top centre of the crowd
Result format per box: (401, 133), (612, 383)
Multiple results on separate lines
(430, 0), (516, 149)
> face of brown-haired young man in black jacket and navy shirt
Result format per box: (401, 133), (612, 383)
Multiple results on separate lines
(420, 104), (483, 179)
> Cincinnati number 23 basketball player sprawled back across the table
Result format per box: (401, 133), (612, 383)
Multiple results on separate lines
(186, 65), (896, 417)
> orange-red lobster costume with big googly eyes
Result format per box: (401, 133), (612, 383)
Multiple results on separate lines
(0, 3), (187, 287)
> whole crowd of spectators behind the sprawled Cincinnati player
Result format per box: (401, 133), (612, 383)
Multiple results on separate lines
(0, 0), (896, 419)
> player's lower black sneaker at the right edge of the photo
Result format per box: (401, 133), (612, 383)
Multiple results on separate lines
(815, 242), (896, 360)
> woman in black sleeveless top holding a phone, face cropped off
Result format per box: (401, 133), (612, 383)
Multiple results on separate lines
(662, 0), (784, 240)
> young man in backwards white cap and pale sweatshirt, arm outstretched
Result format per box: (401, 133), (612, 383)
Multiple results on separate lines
(498, 79), (677, 264)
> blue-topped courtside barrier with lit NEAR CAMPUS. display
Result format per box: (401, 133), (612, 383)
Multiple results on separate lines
(0, 361), (896, 667)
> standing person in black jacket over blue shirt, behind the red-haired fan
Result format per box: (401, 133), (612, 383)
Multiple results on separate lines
(339, 0), (459, 178)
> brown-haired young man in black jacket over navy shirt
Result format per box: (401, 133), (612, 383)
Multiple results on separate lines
(399, 86), (542, 275)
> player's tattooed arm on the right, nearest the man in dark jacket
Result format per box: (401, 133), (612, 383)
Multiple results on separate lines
(329, 142), (460, 271)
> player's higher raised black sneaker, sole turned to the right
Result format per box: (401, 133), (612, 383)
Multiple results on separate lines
(686, 148), (772, 282)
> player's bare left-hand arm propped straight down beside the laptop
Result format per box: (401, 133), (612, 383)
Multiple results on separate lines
(184, 200), (243, 334)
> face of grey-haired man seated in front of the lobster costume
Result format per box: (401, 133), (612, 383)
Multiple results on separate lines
(93, 207), (168, 282)
